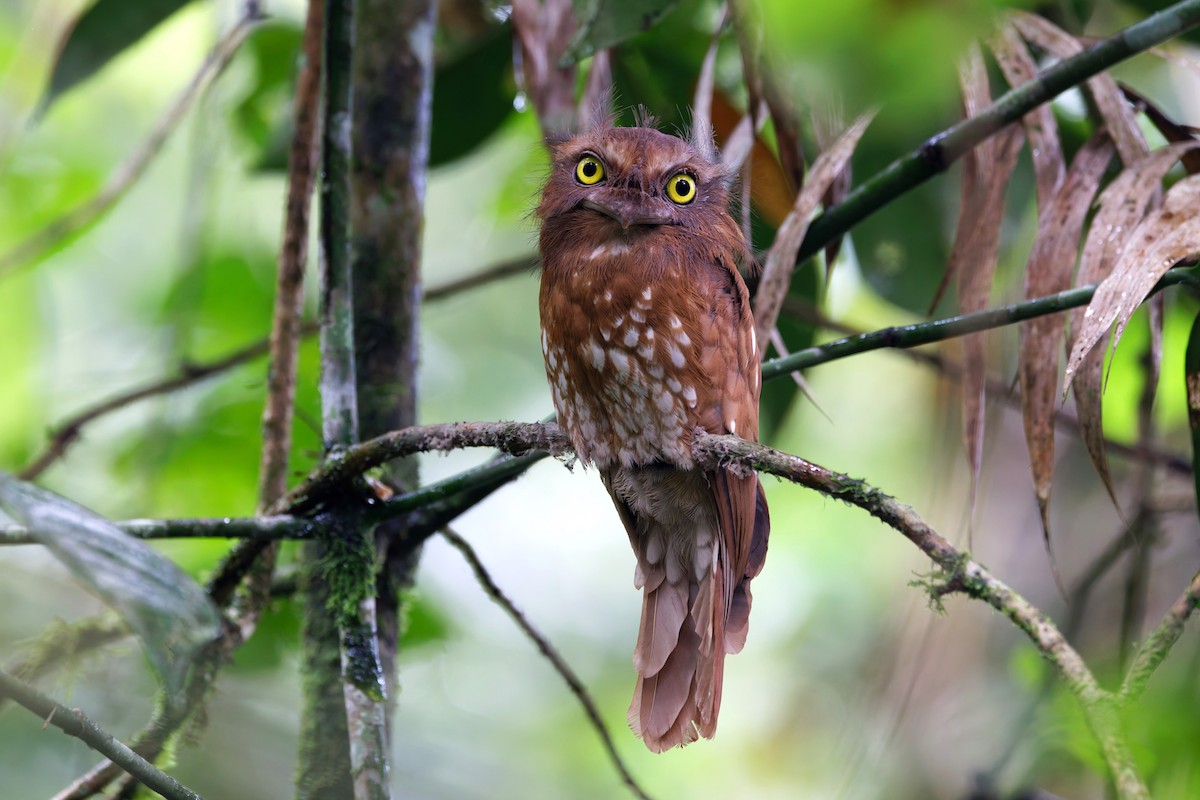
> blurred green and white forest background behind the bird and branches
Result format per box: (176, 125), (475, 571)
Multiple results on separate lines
(0, 0), (1200, 800)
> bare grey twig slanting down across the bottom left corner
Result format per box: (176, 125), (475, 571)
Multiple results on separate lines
(0, 670), (202, 800)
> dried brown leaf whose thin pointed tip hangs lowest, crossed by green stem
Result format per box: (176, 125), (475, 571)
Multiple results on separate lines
(1019, 133), (1114, 589)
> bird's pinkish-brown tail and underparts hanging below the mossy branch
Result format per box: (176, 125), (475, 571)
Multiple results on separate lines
(604, 468), (770, 752)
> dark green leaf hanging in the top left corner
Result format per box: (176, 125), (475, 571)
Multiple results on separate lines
(41, 0), (191, 112)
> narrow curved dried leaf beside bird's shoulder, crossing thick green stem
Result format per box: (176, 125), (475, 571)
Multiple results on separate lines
(754, 112), (875, 354)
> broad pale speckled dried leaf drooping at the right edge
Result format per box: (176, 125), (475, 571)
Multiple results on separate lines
(1062, 143), (1200, 397)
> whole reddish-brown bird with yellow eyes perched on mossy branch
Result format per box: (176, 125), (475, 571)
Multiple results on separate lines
(538, 120), (770, 752)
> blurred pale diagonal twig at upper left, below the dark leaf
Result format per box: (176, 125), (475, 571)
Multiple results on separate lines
(0, 14), (258, 277)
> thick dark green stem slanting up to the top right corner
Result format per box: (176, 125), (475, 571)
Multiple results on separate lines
(797, 0), (1200, 263)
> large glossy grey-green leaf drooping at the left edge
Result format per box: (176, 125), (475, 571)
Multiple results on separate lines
(0, 473), (221, 700)
